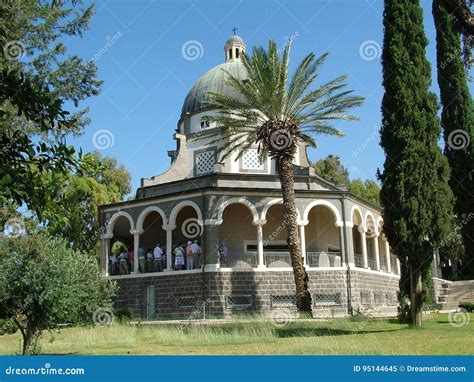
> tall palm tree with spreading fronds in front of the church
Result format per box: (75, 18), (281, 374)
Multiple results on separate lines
(203, 41), (363, 314)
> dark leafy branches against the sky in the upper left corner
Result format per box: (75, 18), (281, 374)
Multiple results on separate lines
(0, 0), (101, 218)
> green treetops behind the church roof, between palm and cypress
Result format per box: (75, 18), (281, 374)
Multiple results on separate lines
(313, 155), (380, 204)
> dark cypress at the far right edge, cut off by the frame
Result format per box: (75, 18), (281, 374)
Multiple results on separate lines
(433, 0), (474, 277)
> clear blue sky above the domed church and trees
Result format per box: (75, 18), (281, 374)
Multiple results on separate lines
(67, 0), (470, 193)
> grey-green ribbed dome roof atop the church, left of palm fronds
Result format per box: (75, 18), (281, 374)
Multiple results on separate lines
(181, 59), (247, 116)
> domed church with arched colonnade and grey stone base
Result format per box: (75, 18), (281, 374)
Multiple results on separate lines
(99, 35), (400, 319)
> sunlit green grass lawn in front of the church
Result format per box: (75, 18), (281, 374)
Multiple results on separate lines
(0, 313), (474, 355)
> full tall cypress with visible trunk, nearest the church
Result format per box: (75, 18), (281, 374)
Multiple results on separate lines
(379, 0), (453, 326)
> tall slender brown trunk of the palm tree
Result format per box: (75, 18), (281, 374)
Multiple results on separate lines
(277, 156), (312, 316)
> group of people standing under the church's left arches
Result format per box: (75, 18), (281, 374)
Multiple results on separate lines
(109, 240), (203, 275)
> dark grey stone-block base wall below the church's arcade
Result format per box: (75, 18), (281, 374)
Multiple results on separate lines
(115, 269), (398, 319)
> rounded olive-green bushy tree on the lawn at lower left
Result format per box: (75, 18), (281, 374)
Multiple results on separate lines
(0, 233), (115, 354)
